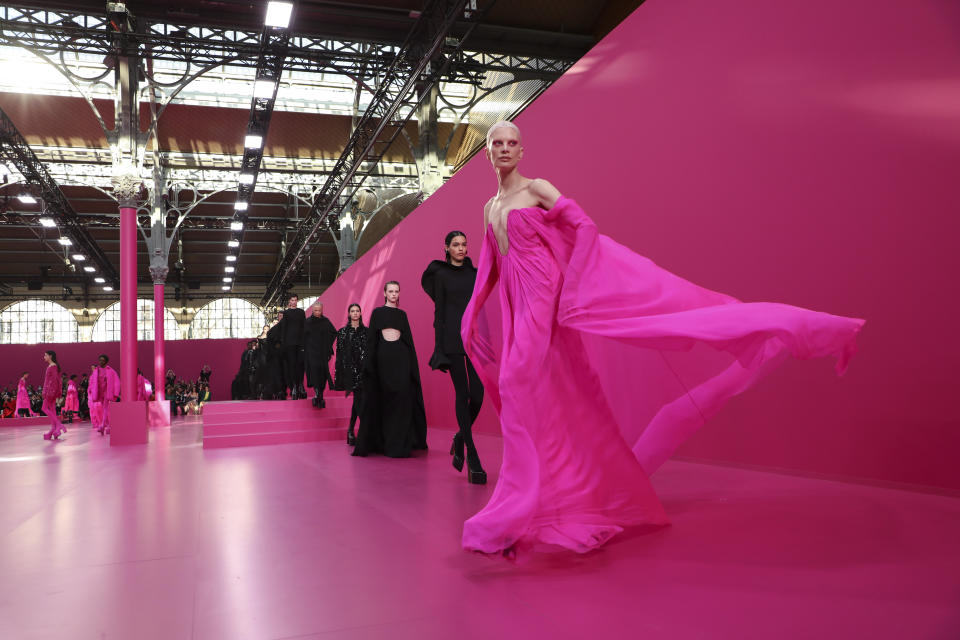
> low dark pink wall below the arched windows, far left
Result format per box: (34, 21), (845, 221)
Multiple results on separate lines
(0, 339), (247, 400)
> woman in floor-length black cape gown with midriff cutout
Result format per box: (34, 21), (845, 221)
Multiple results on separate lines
(353, 282), (427, 458)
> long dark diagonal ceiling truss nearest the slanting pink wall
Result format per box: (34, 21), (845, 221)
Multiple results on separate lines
(260, 0), (495, 307)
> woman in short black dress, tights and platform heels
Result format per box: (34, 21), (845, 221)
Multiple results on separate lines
(420, 231), (487, 484)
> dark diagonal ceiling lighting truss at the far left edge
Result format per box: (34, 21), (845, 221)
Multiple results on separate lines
(0, 110), (120, 286)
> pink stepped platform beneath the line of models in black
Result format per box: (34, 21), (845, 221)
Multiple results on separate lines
(203, 393), (353, 449)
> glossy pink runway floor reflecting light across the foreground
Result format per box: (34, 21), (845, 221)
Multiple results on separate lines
(0, 418), (960, 640)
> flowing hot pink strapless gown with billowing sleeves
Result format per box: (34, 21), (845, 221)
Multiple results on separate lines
(462, 197), (863, 553)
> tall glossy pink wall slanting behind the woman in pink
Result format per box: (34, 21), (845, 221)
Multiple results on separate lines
(322, 0), (960, 490)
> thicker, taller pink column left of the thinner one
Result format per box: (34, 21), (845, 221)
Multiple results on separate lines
(120, 205), (137, 402)
